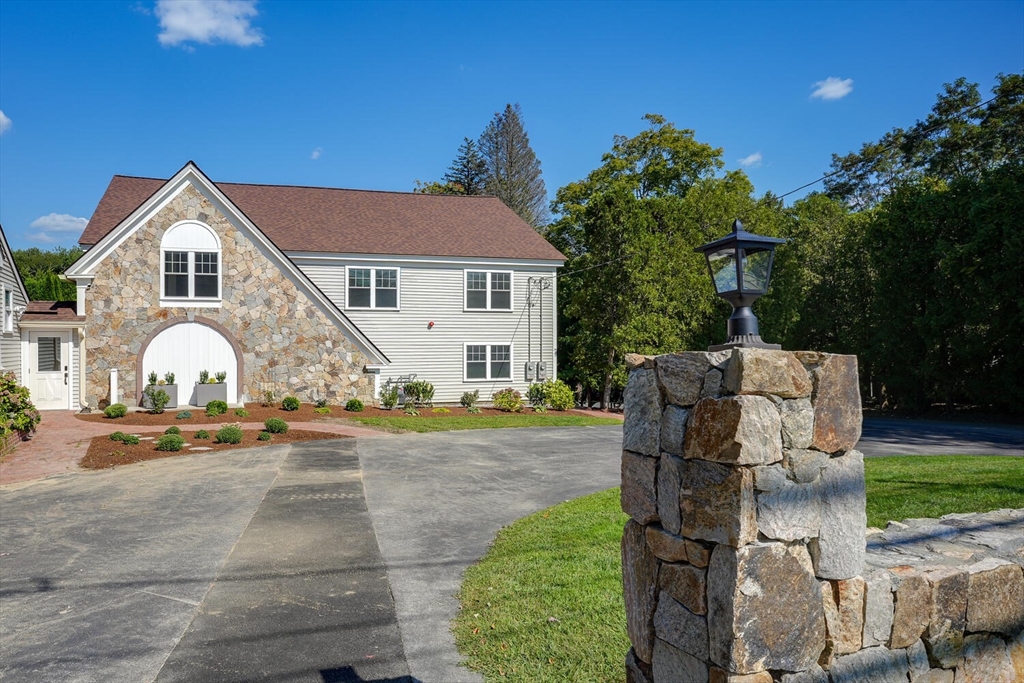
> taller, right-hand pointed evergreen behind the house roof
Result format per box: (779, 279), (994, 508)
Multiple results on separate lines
(479, 104), (550, 228)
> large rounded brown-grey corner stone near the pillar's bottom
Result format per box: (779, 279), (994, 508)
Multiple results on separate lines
(708, 543), (825, 674)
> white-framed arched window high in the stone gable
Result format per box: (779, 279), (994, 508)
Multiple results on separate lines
(160, 220), (220, 306)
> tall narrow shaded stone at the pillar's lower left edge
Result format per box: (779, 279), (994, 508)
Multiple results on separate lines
(623, 519), (657, 664)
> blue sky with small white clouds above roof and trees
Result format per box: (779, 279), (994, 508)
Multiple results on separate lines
(0, 0), (1024, 249)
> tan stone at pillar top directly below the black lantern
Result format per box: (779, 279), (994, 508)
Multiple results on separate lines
(725, 348), (813, 398)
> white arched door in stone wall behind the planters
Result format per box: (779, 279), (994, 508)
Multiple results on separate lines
(142, 323), (239, 405)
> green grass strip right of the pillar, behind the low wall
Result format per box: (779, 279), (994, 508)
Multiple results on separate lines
(864, 456), (1024, 528)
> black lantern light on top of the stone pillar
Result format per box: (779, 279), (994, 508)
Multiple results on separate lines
(693, 220), (785, 351)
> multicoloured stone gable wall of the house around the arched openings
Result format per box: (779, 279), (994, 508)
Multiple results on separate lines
(84, 185), (373, 408)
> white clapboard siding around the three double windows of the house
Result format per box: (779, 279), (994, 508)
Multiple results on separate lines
(293, 256), (556, 403)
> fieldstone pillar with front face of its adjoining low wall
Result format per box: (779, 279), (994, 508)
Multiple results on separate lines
(622, 349), (1024, 683)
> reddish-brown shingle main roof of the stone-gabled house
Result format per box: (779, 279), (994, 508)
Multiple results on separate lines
(79, 175), (564, 260)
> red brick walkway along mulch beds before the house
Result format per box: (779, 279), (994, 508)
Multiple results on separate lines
(0, 411), (383, 485)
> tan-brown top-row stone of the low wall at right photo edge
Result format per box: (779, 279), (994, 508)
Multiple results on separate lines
(967, 557), (1024, 636)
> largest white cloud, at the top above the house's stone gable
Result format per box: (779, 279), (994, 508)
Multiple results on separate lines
(157, 0), (263, 48)
